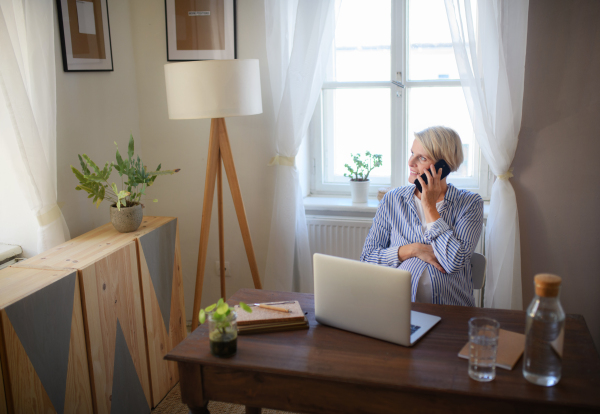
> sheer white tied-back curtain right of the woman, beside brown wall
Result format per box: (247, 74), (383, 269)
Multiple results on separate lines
(445, 0), (529, 309)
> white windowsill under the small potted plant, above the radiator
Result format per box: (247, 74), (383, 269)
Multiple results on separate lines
(304, 195), (490, 220)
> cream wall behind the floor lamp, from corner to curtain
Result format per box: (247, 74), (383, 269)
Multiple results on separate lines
(131, 0), (274, 320)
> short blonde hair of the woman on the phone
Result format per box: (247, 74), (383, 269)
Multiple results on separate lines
(415, 126), (464, 171)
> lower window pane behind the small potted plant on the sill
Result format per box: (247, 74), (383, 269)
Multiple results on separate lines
(323, 88), (392, 183)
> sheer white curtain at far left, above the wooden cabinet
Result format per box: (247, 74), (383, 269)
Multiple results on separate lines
(0, 0), (69, 253)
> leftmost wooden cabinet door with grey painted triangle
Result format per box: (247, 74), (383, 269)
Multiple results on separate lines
(0, 270), (92, 413)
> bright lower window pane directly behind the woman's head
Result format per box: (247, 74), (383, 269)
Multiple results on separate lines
(406, 86), (479, 180)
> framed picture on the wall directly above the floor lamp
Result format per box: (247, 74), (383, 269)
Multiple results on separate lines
(165, 0), (236, 61)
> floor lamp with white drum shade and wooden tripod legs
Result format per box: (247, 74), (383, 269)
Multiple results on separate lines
(165, 59), (262, 330)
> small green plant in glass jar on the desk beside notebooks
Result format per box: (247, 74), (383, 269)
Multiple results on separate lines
(198, 298), (252, 358)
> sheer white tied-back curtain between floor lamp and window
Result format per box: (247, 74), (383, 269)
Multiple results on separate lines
(265, 0), (335, 292)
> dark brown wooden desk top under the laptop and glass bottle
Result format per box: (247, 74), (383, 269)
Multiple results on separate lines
(165, 289), (600, 409)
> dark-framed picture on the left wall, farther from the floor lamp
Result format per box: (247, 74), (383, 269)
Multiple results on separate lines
(56, 0), (113, 72)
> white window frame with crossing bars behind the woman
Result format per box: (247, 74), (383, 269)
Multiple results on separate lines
(308, 0), (492, 200)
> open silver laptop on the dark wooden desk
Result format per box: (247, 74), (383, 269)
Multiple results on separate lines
(313, 253), (441, 346)
